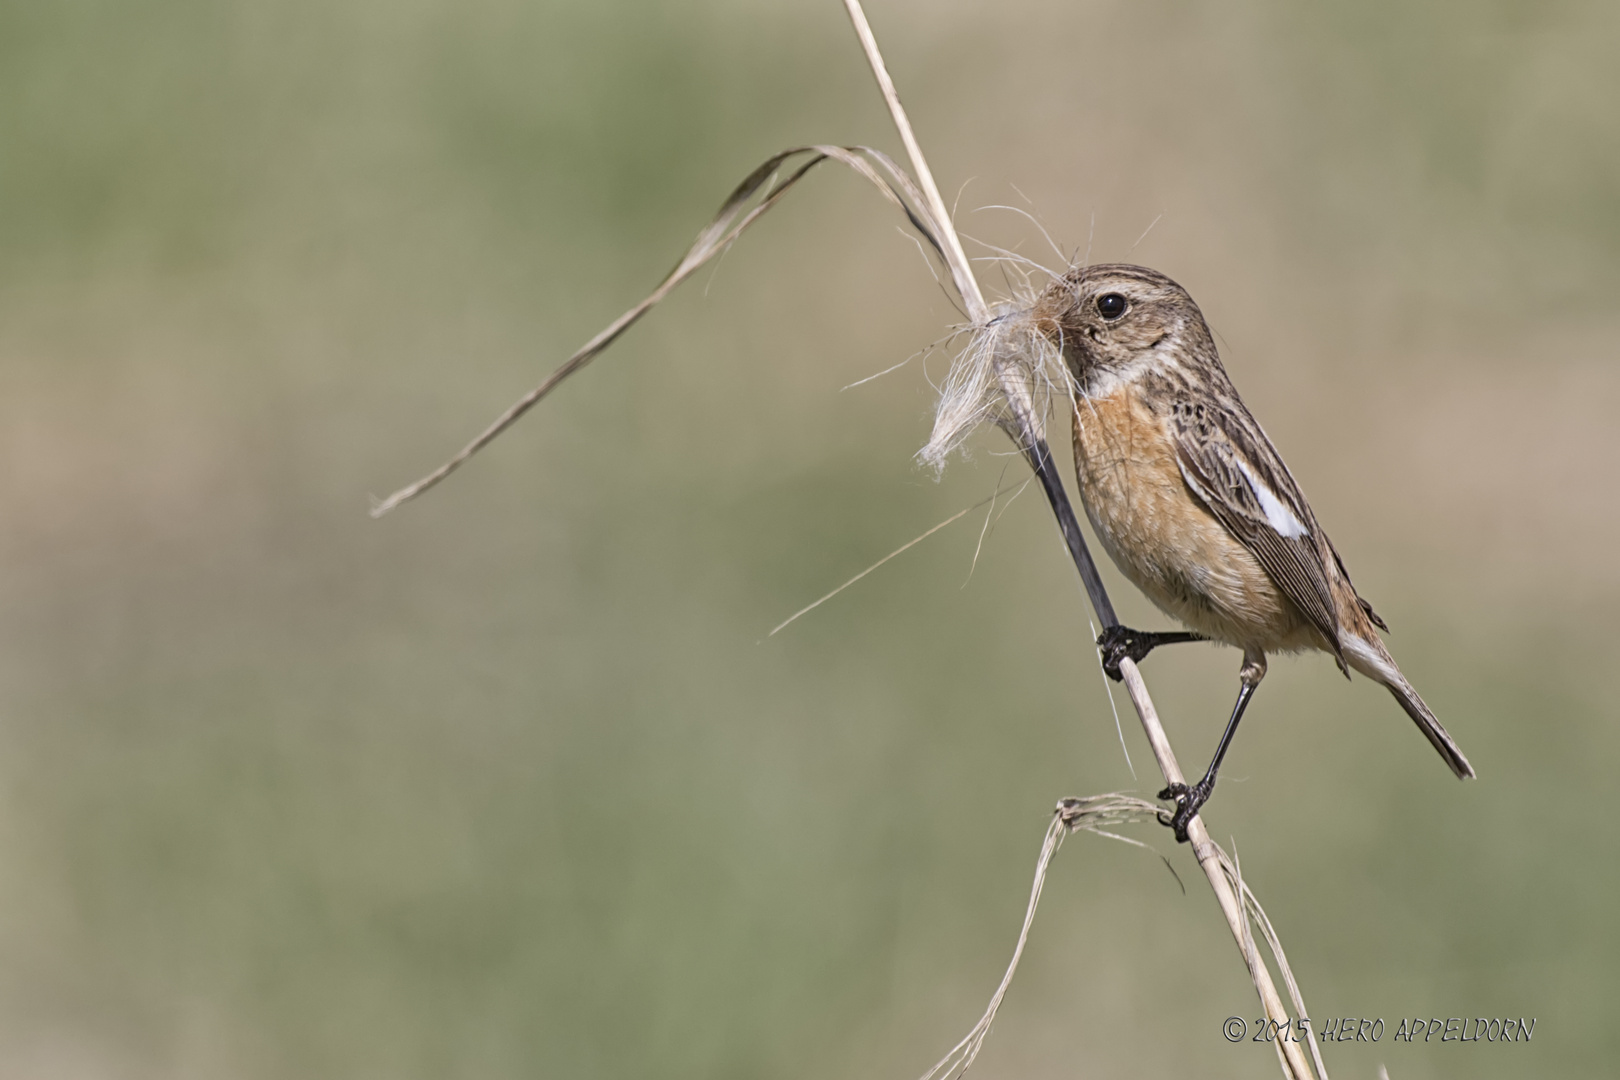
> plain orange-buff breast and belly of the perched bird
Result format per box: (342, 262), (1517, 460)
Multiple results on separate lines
(1074, 384), (1311, 651)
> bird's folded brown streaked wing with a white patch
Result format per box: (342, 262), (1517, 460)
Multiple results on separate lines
(1170, 403), (1345, 667)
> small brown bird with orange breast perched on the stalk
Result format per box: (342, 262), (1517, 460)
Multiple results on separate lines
(1035, 264), (1474, 840)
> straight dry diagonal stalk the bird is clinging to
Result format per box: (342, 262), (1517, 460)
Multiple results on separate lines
(844, 0), (1314, 1080)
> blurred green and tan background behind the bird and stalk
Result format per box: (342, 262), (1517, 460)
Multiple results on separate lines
(0, 0), (1620, 1080)
